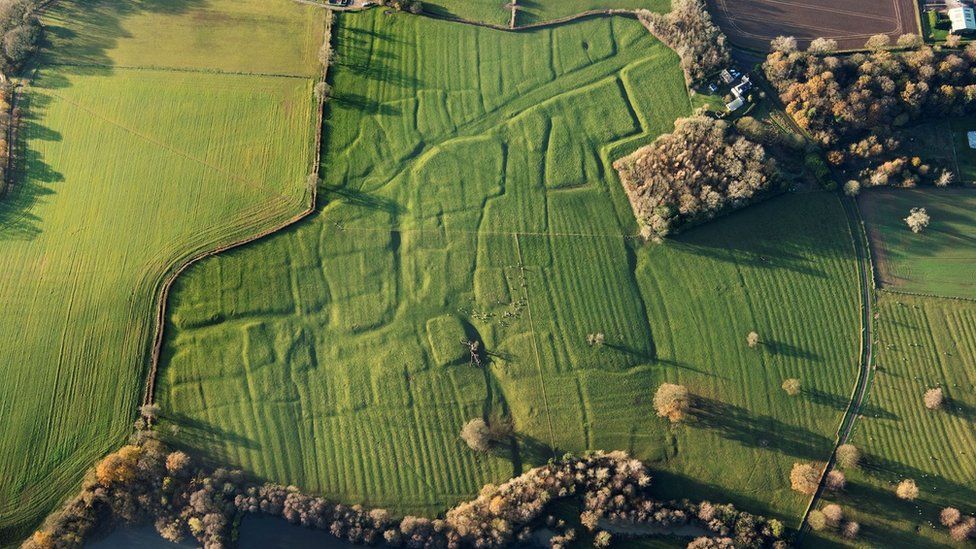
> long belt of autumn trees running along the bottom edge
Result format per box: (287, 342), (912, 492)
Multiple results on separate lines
(23, 429), (787, 549)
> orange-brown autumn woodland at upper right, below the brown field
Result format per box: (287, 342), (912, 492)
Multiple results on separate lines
(764, 35), (976, 187)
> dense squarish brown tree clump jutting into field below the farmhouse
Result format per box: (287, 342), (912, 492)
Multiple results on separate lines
(614, 116), (779, 237)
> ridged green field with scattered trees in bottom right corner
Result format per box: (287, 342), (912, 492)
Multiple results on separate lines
(816, 293), (976, 547)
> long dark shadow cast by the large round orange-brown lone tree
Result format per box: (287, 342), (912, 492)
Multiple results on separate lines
(688, 396), (833, 460)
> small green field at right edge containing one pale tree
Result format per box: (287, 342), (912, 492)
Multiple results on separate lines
(858, 188), (976, 298)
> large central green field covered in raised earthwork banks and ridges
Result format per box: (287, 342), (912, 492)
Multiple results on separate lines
(156, 10), (858, 524)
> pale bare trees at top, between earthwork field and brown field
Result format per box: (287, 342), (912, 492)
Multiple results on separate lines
(637, 0), (731, 85)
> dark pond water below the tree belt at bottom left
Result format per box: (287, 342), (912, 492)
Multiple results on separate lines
(85, 516), (353, 549)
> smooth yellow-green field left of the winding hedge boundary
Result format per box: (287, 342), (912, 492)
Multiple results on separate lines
(0, 0), (323, 544)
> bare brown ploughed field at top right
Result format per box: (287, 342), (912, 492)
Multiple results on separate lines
(708, 0), (919, 51)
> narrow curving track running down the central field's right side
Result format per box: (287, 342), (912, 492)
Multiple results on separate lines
(796, 193), (874, 545)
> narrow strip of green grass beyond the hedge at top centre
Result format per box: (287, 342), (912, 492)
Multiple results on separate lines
(424, 0), (671, 26)
